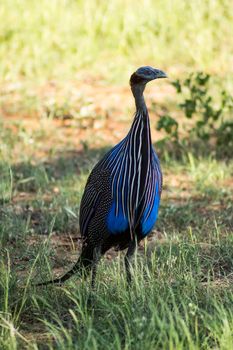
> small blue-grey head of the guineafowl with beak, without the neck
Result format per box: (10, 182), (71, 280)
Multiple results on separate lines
(130, 66), (167, 87)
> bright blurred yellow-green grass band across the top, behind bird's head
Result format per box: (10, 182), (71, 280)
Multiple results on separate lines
(0, 0), (233, 82)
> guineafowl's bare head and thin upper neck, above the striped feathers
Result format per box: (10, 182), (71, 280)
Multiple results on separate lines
(130, 66), (167, 112)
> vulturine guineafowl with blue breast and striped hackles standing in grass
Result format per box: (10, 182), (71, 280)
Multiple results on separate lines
(37, 66), (167, 287)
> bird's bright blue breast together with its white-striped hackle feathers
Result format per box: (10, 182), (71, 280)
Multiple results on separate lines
(101, 111), (162, 235)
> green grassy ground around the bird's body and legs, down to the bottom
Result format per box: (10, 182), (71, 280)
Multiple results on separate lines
(0, 117), (233, 350)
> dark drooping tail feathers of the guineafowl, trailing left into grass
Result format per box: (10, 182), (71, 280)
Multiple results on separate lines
(35, 249), (93, 286)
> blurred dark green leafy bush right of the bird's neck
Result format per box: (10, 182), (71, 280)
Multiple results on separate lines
(157, 72), (233, 156)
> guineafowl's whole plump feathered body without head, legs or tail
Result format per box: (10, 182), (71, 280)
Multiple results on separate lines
(80, 110), (162, 244)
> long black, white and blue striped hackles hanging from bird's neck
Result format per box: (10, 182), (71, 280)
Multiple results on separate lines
(100, 109), (155, 234)
